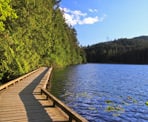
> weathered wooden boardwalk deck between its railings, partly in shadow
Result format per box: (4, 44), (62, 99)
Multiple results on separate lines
(0, 68), (87, 122)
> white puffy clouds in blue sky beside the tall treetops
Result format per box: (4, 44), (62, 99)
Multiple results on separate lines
(60, 8), (104, 26)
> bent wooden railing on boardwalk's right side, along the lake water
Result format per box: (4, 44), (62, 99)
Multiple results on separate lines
(41, 68), (88, 122)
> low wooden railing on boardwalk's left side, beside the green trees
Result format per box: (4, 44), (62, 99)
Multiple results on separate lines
(0, 68), (40, 91)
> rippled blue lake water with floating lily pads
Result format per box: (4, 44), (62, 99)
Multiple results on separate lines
(51, 64), (148, 122)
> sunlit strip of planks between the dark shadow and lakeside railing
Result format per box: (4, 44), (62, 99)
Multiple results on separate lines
(33, 69), (68, 122)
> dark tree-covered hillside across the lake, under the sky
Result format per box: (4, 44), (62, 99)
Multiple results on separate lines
(85, 36), (148, 64)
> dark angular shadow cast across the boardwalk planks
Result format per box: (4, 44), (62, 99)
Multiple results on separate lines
(19, 70), (52, 122)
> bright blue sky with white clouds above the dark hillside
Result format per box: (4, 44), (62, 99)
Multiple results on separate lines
(60, 0), (148, 46)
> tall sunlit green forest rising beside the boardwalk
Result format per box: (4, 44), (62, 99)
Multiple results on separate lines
(0, 0), (86, 83)
